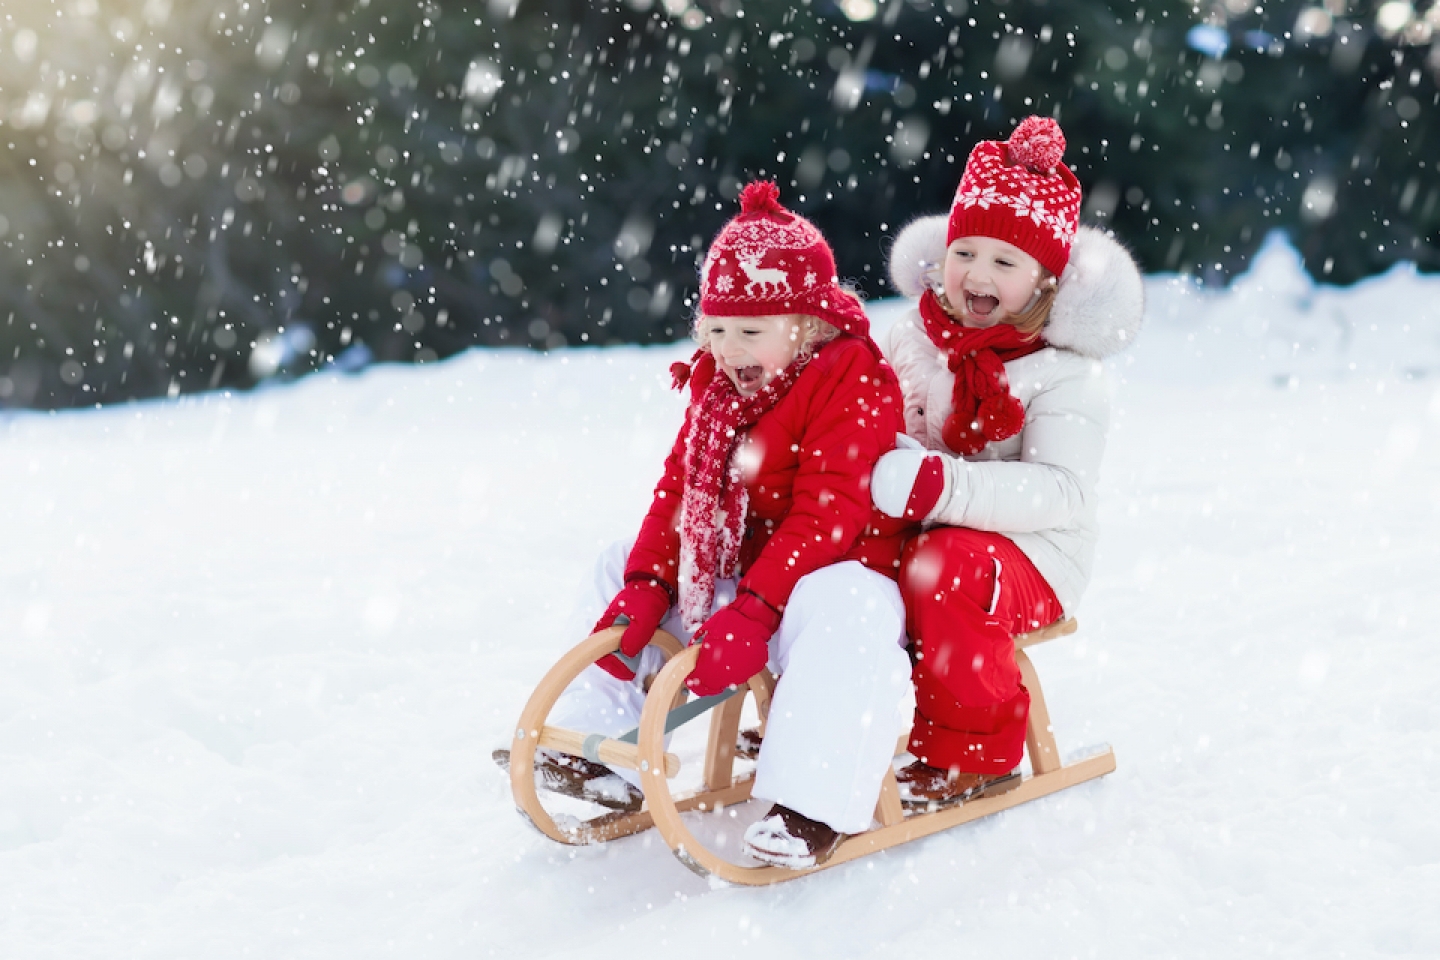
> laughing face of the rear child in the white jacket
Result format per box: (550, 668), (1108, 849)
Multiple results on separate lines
(945, 236), (1045, 327)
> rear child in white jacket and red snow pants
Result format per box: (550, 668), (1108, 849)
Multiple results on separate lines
(871, 117), (1143, 805)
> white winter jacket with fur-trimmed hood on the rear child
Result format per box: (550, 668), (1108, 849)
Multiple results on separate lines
(880, 216), (1145, 615)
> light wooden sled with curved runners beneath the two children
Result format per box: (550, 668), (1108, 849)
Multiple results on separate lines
(510, 619), (1115, 885)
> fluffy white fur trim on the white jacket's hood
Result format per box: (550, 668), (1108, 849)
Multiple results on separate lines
(890, 214), (1145, 360)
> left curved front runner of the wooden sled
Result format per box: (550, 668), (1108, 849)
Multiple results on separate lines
(510, 626), (683, 845)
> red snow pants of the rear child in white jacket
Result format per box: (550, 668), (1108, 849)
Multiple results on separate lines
(900, 527), (1063, 774)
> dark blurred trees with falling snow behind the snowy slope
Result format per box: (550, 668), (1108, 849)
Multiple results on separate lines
(0, 0), (1440, 409)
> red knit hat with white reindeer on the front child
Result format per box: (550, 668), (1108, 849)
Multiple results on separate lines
(700, 180), (870, 337)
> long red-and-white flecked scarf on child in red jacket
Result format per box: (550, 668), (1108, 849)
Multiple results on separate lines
(677, 348), (819, 630)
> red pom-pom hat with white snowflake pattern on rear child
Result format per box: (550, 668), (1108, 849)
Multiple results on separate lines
(945, 117), (1080, 276)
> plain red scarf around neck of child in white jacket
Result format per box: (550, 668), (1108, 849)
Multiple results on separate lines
(920, 291), (1047, 455)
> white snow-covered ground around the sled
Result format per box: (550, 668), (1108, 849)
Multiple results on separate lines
(0, 234), (1440, 960)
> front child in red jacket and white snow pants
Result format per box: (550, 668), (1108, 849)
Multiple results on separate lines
(539, 183), (910, 868)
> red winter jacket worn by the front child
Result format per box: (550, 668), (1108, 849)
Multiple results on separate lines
(625, 335), (913, 612)
